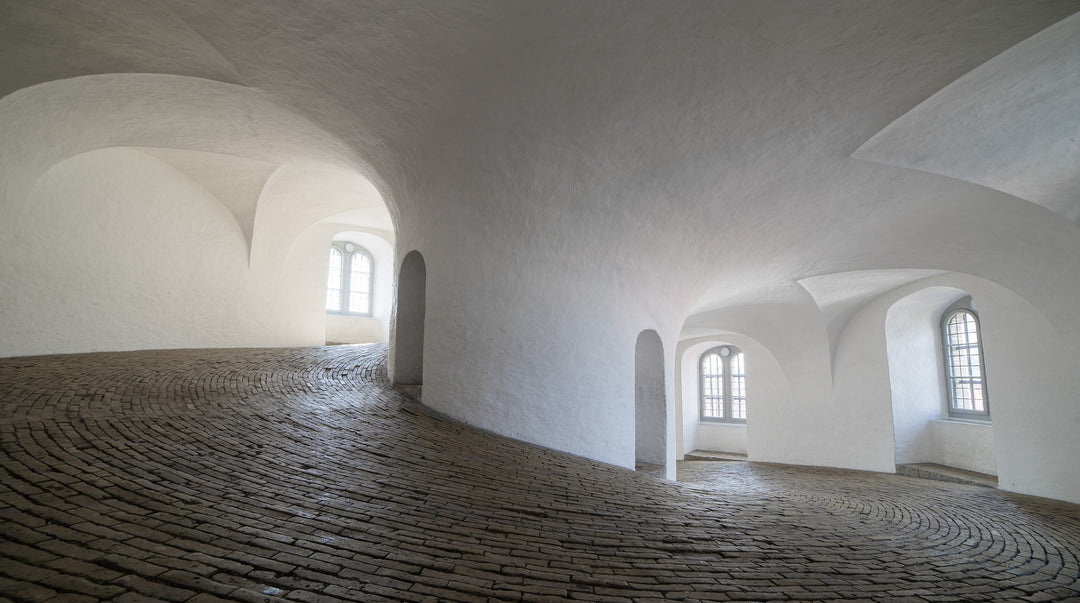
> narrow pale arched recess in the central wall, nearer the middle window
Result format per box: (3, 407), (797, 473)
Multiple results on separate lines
(634, 329), (667, 471)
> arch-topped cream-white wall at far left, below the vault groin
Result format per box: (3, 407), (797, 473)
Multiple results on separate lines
(0, 149), (285, 356)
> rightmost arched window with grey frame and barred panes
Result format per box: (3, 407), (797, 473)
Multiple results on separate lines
(942, 308), (990, 419)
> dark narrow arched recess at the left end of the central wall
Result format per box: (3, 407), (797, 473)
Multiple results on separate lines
(390, 250), (428, 386)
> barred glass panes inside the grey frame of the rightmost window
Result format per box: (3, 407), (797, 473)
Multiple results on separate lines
(945, 311), (986, 413)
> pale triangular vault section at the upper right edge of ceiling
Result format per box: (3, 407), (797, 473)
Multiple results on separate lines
(852, 13), (1080, 222)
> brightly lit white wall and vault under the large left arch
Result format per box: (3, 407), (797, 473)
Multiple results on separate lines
(0, 75), (392, 356)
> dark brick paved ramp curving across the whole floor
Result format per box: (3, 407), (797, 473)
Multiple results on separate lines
(0, 347), (1080, 601)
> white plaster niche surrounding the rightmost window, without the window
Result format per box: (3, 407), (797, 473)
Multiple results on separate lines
(886, 285), (993, 475)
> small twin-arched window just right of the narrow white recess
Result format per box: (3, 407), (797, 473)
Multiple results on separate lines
(700, 346), (746, 423)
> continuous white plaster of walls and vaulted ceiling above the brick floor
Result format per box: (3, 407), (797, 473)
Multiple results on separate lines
(0, 0), (1080, 500)
